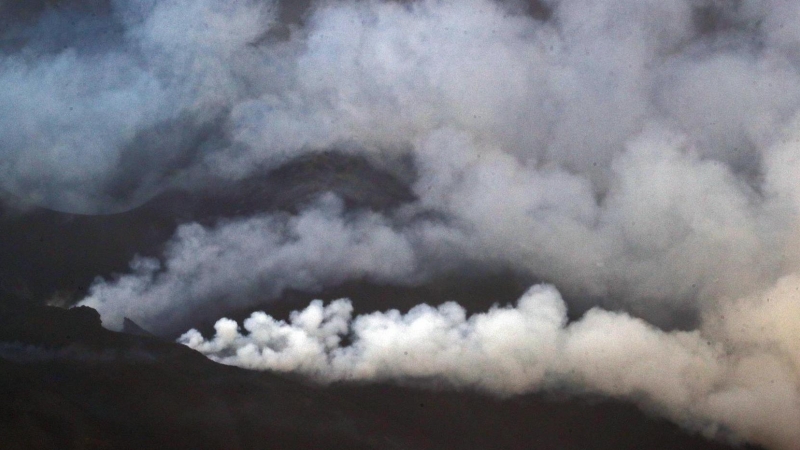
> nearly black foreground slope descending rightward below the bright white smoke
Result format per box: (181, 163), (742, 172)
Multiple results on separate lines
(0, 307), (756, 450)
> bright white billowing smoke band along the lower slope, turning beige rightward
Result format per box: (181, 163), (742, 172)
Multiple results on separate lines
(180, 284), (800, 449)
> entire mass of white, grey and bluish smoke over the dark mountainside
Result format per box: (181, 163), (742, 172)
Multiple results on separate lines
(6, 0), (800, 449)
